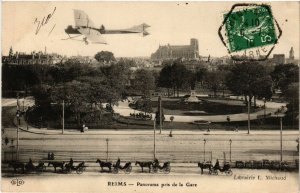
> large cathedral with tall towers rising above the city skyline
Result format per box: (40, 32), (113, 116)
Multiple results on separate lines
(151, 38), (199, 60)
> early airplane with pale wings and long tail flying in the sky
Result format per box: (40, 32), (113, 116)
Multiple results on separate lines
(63, 9), (150, 44)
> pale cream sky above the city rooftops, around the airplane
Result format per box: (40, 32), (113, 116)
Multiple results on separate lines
(2, 2), (300, 58)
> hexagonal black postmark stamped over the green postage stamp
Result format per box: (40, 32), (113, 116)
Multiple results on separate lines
(219, 4), (282, 61)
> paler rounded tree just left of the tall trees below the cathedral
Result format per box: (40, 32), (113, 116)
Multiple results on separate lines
(133, 69), (155, 97)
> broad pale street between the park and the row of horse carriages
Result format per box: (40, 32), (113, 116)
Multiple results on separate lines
(3, 128), (298, 163)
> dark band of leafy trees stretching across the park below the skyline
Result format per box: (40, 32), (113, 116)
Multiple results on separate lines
(2, 51), (299, 124)
